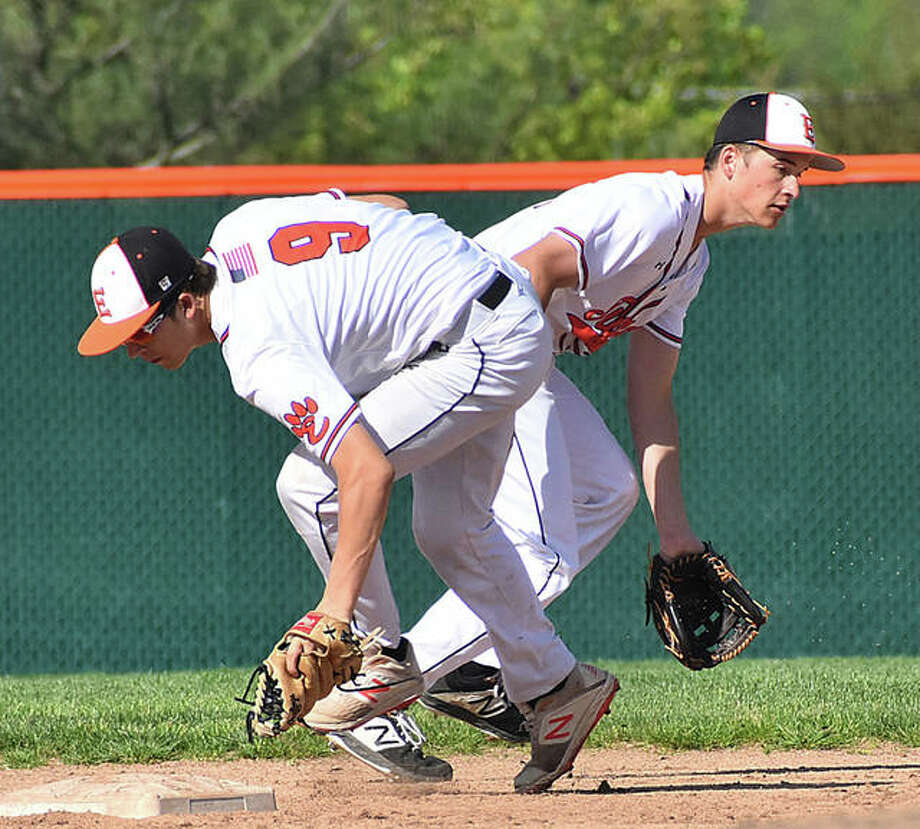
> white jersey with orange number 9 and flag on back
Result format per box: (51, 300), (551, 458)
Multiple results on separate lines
(204, 191), (510, 462)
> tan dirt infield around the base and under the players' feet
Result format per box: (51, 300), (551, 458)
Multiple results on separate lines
(0, 746), (920, 829)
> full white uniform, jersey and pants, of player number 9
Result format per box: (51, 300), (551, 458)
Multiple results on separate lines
(222, 193), (575, 705)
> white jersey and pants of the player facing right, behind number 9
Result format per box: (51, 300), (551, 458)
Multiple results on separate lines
(407, 173), (709, 686)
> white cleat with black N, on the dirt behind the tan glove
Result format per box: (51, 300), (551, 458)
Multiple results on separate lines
(326, 711), (454, 783)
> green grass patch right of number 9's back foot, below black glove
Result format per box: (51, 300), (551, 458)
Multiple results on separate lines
(592, 658), (920, 750)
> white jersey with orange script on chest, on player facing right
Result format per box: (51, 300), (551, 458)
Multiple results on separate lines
(476, 172), (709, 354)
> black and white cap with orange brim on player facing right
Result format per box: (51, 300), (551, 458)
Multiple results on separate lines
(712, 92), (846, 172)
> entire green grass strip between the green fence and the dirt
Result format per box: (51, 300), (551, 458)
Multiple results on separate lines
(0, 658), (920, 767)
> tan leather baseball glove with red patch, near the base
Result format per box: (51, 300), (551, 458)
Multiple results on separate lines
(237, 611), (376, 742)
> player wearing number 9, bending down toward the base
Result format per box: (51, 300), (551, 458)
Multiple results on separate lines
(78, 191), (618, 792)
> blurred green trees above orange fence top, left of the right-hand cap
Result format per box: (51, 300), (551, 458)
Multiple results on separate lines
(0, 0), (764, 167)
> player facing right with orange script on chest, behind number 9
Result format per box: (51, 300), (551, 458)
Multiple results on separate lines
(321, 93), (844, 777)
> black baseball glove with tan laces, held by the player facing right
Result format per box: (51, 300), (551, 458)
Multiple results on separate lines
(645, 541), (770, 671)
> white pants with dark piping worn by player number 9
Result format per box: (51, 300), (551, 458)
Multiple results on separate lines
(277, 272), (575, 702)
